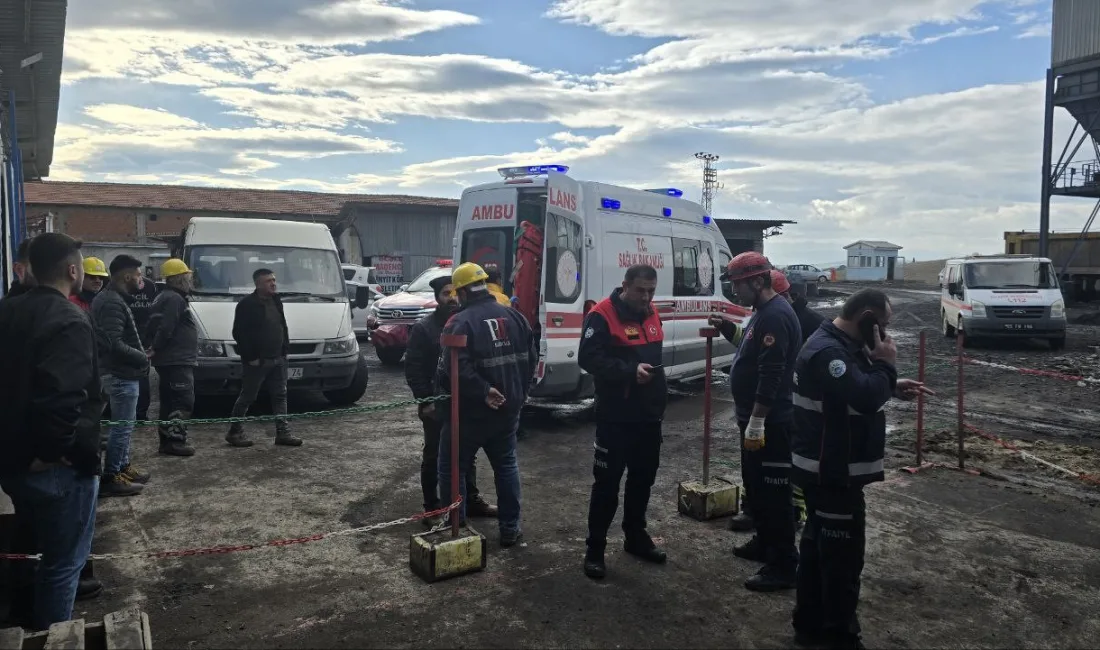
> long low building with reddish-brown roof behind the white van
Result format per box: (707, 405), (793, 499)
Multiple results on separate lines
(25, 181), (459, 280)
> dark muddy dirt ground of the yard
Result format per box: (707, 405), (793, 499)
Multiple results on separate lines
(34, 286), (1100, 648)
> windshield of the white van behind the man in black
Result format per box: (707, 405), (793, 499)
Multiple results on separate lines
(186, 244), (348, 299)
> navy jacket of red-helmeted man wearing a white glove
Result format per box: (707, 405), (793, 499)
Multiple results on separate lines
(729, 296), (802, 422)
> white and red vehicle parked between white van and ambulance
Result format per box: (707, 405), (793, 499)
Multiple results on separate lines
(366, 260), (451, 365)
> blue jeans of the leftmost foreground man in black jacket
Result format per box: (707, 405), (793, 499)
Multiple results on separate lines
(0, 465), (99, 629)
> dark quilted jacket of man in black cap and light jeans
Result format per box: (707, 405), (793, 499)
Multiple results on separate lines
(91, 285), (149, 379)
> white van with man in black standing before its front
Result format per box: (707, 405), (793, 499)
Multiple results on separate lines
(180, 217), (367, 406)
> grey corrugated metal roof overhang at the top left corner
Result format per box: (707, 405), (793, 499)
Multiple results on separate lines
(0, 0), (68, 179)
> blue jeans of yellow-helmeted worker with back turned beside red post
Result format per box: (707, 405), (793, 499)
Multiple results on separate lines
(439, 415), (520, 533)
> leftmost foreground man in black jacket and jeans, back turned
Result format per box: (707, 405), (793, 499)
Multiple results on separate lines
(0, 233), (103, 629)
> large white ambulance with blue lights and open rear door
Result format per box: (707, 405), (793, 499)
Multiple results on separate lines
(454, 165), (751, 403)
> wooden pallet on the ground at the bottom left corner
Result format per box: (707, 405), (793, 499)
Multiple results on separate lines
(0, 607), (153, 650)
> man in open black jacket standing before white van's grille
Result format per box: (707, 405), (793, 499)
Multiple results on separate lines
(226, 268), (301, 447)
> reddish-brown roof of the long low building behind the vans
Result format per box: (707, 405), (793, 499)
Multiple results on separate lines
(25, 180), (459, 218)
